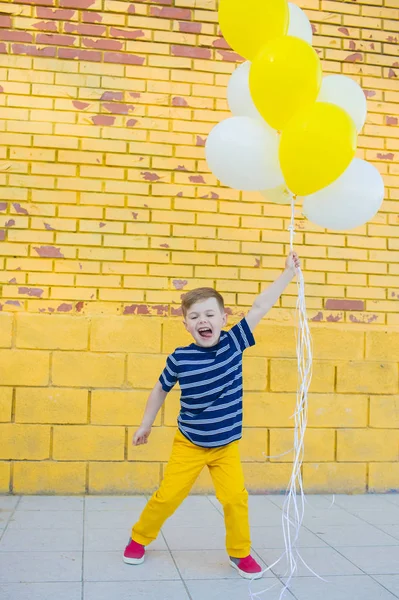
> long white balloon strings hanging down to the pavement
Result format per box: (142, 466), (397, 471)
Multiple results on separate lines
(249, 194), (318, 600)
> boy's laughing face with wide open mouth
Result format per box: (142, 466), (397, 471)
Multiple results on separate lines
(184, 298), (227, 348)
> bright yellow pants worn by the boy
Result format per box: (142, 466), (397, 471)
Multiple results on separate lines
(132, 431), (251, 558)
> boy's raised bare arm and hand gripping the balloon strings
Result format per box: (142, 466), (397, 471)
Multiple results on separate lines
(246, 252), (300, 331)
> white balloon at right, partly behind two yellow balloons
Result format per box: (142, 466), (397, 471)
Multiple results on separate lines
(318, 75), (367, 131)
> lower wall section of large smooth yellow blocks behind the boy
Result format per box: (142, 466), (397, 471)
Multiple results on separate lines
(0, 313), (399, 493)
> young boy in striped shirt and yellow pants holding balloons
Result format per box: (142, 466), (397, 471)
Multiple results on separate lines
(123, 252), (299, 579)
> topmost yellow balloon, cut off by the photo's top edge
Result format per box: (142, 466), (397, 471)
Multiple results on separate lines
(219, 0), (289, 60)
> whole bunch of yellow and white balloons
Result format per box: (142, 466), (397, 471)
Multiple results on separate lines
(206, 0), (384, 230)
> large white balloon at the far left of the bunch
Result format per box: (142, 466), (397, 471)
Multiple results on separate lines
(205, 117), (283, 191)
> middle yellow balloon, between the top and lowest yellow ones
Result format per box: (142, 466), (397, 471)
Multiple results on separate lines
(249, 36), (322, 131)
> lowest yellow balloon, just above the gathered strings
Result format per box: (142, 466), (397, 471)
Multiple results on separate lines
(279, 102), (357, 196)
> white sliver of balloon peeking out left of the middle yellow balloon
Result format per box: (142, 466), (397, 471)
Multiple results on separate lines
(227, 61), (266, 123)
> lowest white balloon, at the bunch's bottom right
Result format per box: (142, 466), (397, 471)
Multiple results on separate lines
(302, 158), (384, 231)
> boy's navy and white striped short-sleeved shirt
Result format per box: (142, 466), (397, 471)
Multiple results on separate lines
(159, 319), (255, 448)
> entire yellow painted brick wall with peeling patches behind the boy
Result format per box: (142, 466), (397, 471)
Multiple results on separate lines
(0, 0), (399, 493)
